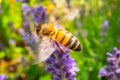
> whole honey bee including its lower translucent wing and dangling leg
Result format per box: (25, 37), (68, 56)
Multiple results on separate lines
(24, 8), (81, 64)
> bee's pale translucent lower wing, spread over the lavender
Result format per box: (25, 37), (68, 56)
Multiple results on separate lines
(34, 36), (55, 64)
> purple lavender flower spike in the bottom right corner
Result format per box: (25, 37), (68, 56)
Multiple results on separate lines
(99, 47), (120, 80)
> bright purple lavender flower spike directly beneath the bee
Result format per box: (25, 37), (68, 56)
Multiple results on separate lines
(46, 46), (79, 80)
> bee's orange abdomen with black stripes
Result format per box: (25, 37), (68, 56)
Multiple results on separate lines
(54, 29), (81, 51)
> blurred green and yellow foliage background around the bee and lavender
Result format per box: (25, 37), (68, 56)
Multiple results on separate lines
(0, 0), (120, 80)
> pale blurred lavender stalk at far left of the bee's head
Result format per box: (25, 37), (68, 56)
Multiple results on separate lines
(19, 3), (36, 49)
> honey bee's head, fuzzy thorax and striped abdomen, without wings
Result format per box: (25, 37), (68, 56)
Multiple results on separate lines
(36, 23), (81, 51)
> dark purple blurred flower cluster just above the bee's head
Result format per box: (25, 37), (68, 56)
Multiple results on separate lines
(32, 6), (47, 24)
